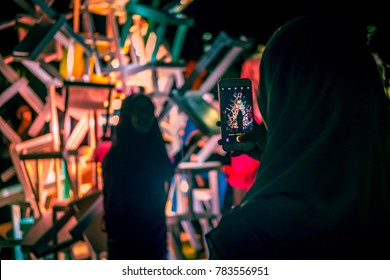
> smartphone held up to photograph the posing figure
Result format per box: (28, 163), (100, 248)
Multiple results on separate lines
(218, 78), (255, 152)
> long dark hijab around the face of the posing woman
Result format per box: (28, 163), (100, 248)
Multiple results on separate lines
(103, 94), (174, 237)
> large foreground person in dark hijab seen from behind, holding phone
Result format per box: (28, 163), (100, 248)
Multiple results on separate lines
(207, 16), (390, 260)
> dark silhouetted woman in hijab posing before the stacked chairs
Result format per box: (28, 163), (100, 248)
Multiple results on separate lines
(103, 94), (174, 260)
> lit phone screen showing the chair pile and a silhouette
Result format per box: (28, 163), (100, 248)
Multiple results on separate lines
(220, 86), (254, 143)
